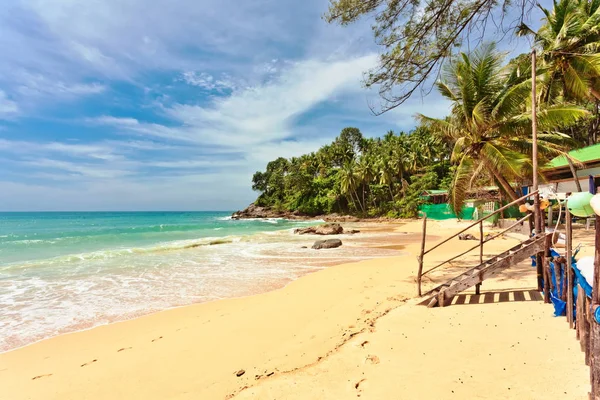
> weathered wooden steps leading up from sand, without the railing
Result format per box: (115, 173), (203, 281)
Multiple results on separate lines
(420, 234), (548, 307)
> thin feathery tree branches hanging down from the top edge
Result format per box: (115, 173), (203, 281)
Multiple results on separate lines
(325, 0), (536, 112)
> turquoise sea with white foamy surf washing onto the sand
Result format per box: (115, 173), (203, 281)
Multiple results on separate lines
(0, 212), (404, 351)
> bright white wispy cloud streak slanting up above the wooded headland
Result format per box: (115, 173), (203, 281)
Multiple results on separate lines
(98, 54), (376, 152)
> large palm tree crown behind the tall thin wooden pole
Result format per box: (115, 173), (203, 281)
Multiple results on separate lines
(418, 44), (586, 215)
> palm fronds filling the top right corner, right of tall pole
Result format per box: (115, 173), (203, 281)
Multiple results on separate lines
(519, 0), (600, 103)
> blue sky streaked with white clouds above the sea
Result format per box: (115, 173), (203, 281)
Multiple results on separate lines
(0, 0), (544, 211)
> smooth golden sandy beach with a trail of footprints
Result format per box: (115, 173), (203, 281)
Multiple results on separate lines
(0, 221), (591, 400)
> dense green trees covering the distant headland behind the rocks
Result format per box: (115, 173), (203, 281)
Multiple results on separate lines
(252, 127), (449, 216)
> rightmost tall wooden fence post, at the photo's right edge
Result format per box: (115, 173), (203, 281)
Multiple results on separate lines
(590, 215), (600, 400)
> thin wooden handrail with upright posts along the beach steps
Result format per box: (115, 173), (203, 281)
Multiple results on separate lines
(417, 191), (538, 296)
